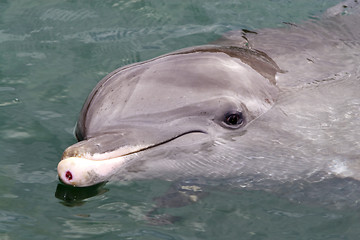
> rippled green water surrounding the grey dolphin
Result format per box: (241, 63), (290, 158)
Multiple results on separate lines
(0, 0), (360, 239)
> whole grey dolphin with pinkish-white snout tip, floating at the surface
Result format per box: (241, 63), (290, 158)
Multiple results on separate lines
(58, 0), (360, 186)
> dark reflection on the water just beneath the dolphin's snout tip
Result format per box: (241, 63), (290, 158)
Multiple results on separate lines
(55, 183), (109, 207)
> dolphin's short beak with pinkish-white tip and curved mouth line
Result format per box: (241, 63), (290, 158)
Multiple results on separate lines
(57, 130), (208, 187)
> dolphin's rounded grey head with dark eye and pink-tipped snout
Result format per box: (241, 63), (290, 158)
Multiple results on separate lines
(58, 45), (280, 186)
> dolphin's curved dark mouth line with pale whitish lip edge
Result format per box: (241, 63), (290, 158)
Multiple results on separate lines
(61, 130), (208, 161)
